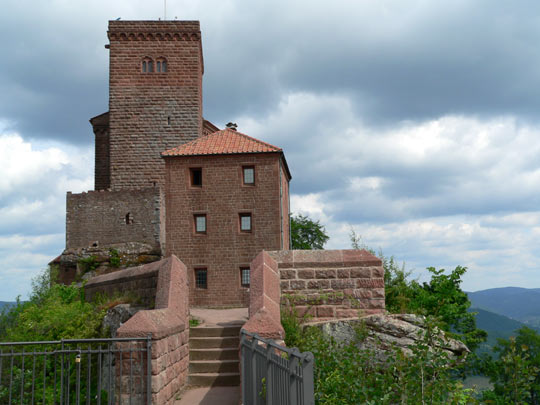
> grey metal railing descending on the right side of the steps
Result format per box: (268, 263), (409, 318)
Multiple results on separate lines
(240, 330), (315, 405)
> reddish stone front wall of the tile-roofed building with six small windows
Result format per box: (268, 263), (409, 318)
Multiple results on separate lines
(165, 153), (288, 306)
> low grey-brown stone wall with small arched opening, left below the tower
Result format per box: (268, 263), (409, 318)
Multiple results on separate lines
(66, 187), (162, 249)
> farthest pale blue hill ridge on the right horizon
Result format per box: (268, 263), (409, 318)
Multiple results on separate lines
(467, 287), (540, 328)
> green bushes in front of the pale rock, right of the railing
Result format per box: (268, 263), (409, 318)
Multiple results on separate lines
(284, 321), (478, 405)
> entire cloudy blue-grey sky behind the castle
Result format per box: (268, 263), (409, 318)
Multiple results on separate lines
(0, 0), (540, 300)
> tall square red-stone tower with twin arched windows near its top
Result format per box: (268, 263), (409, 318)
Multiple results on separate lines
(108, 21), (203, 189)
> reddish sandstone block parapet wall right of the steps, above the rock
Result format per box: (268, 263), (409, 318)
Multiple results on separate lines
(268, 250), (385, 319)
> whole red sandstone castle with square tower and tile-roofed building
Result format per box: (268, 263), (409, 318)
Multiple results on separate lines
(56, 21), (291, 307)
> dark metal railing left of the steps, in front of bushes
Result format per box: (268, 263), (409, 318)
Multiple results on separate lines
(0, 337), (152, 405)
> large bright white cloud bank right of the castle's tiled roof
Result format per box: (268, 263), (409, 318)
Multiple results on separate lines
(249, 93), (540, 290)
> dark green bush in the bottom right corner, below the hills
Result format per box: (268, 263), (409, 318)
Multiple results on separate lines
(483, 327), (540, 404)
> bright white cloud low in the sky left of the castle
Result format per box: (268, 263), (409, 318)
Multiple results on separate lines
(0, 134), (93, 301)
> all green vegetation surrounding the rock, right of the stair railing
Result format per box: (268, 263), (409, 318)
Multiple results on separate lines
(282, 224), (540, 405)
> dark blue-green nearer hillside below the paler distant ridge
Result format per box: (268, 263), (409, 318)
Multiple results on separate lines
(470, 308), (540, 353)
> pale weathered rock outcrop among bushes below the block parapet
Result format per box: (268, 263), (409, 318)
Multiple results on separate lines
(312, 314), (470, 360)
